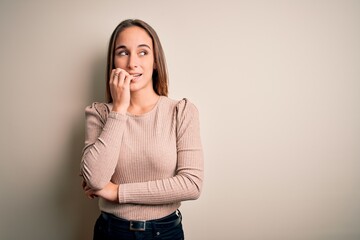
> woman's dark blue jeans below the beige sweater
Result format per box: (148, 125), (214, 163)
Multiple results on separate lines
(93, 212), (184, 240)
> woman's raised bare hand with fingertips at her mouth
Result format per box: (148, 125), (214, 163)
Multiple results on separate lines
(109, 68), (133, 114)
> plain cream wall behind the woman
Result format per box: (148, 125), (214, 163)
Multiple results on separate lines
(0, 0), (360, 240)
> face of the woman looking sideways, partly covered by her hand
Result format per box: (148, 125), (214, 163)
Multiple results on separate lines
(114, 26), (154, 91)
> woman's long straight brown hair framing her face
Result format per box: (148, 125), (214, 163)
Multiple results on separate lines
(105, 19), (168, 103)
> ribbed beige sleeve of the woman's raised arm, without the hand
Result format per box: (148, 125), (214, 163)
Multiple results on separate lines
(80, 103), (127, 190)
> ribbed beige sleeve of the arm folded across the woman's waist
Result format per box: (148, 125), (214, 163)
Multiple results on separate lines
(119, 99), (204, 205)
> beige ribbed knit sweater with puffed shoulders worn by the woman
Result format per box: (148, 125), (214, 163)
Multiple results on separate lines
(80, 96), (204, 220)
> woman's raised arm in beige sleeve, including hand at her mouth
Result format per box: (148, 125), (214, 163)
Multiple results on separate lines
(80, 68), (133, 191)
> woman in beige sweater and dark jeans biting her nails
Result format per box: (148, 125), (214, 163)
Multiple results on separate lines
(81, 19), (203, 240)
